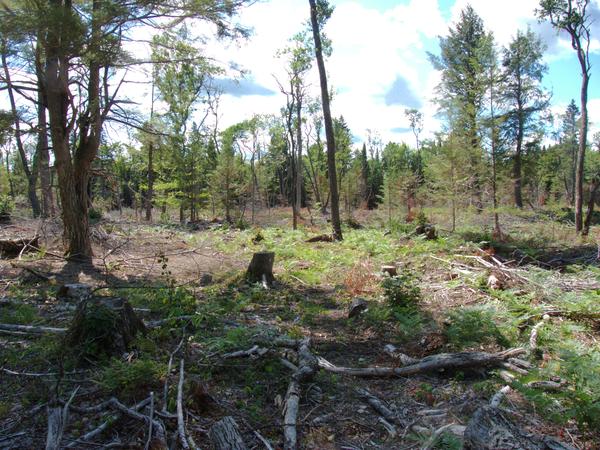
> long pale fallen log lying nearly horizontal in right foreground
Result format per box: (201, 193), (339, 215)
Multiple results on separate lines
(317, 348), (525, 377)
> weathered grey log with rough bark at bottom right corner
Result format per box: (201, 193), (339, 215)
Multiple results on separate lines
(464, 405), (574, 450)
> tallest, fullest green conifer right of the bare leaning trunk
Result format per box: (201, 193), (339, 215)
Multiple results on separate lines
(430, 5), (492, 210)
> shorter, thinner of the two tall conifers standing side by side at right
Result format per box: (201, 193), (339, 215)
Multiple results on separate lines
(502, 30), (548, 208)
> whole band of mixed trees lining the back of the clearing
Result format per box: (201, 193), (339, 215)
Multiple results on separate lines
(0, 0), (600, 258)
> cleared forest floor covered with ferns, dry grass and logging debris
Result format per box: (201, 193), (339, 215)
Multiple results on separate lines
(0, 209), (600, 449)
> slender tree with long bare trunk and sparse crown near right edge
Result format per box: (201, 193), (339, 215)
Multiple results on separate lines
(536, 0), (592, 233)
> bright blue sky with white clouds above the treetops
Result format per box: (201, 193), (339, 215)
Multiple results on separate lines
(189, 0), (600, 144)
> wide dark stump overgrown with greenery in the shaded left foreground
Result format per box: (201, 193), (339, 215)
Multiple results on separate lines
(65, 297), (146, 358)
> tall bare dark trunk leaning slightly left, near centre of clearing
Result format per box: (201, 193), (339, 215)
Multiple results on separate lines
(308, 0), (343, 241)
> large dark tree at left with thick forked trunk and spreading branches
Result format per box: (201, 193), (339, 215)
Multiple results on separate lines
(5, 0), (250, 261)
